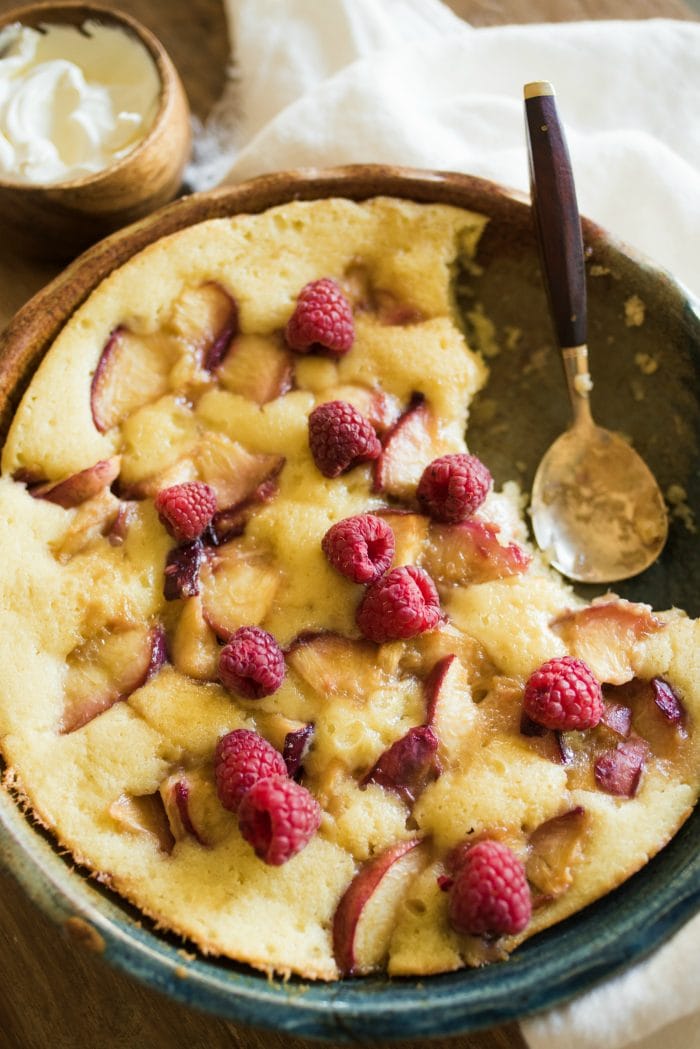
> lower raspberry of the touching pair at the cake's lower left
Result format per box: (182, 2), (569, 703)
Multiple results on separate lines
(238, 775), (321, 866)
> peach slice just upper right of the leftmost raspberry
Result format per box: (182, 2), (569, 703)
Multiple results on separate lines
(192, 432), (284, 511)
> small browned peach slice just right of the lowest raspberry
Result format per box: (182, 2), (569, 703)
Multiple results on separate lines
(525, 806), (586, 902)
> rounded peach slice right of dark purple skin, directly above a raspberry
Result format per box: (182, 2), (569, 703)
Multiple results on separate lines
(199, 539), (280, 641)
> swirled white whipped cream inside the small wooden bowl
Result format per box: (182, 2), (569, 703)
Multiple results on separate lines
(0, 21), (161, 184)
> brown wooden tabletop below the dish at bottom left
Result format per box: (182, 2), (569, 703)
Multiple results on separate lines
(0, 875), (525, 1049)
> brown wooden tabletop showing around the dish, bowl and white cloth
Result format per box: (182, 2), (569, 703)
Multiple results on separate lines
(0, 0), (697, 1049)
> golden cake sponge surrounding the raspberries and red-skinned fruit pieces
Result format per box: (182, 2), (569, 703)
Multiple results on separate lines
(0, 198), (700, 980)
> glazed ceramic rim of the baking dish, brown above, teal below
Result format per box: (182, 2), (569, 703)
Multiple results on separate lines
(0, 165), (700, 1042)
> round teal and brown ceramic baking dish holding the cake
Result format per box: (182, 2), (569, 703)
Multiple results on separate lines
(0, 165), (700, 1043)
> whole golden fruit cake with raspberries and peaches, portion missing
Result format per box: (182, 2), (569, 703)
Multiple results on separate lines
(0, 198), (700, 980)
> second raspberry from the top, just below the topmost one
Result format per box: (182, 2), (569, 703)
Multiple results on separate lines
(309, 401), (382, 477)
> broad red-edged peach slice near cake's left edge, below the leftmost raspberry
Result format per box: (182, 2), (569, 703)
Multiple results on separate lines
(60, 625), (167, 734)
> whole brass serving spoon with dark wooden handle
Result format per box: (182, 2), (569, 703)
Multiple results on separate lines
(525, 81), (669, 583)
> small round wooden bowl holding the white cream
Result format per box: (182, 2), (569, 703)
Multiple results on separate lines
(0, 0), (191, 259)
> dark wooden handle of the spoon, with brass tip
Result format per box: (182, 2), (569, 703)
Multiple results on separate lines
(525, 82), (587, 348)
